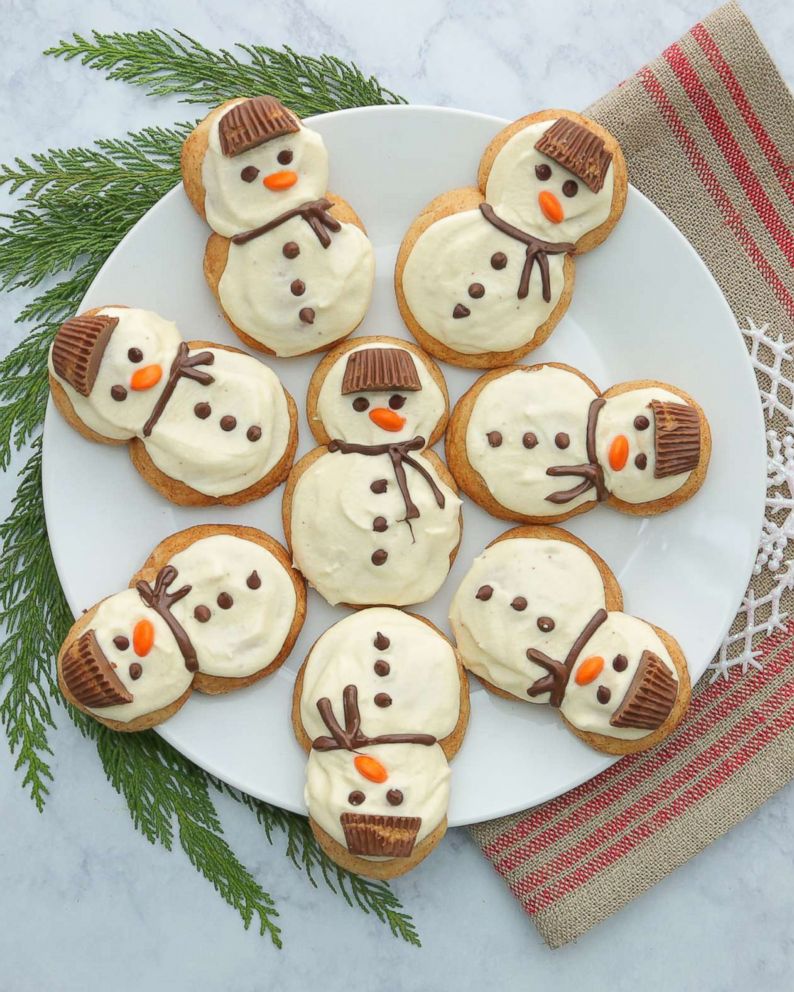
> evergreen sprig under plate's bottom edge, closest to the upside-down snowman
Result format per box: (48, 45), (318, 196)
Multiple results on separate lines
(207, 775), (422, 947)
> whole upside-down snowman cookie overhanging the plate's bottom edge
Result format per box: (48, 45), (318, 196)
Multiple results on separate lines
(292, 607), (469, 878)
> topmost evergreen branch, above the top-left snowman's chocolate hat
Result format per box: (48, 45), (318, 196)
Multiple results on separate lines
(44, 31), (405, 111)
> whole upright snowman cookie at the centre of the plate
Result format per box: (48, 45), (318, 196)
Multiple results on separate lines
(283, 337), (461, 606)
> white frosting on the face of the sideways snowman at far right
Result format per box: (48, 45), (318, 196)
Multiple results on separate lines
(596, 386), (691, 503)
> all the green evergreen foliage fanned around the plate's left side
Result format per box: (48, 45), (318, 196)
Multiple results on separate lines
(0, 31), (419, 947)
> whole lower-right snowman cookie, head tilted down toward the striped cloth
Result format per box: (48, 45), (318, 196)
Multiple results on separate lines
(450, 527), (690, 754)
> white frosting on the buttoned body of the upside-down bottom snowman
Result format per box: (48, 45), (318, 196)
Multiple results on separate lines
(301, 607), (460, 740)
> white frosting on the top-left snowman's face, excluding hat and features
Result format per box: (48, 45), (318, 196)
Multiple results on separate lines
(201, 100), (328, 240)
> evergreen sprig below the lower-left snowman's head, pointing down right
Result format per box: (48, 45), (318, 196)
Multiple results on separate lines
(69, 706), (282, 947)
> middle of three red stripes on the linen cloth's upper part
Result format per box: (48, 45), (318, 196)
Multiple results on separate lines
(662, 43), (794, 266)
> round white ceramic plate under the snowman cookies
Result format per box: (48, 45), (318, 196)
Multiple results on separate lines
(44, 107), (766, 825)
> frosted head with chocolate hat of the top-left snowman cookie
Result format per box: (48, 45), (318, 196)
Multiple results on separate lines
(202, 96), (328, 237)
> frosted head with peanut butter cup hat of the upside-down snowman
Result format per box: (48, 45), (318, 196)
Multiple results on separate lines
(305, 744), (450, 858)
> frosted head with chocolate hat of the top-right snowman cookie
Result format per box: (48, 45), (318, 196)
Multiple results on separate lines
(485, 117), (615, 244)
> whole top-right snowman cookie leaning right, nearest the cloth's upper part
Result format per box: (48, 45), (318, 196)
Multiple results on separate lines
(395, 110), (628, 368)
